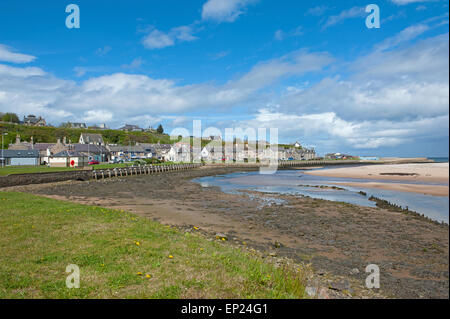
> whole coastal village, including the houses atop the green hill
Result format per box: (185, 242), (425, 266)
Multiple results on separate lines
(1, 115), (318, 167)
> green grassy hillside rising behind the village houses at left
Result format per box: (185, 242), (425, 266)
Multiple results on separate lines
(0, 123), (175, 149)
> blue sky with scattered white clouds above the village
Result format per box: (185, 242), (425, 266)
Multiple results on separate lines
(0, 0), (449, 156)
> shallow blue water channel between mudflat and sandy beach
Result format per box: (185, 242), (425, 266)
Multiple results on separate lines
(194, 170), (449, 223)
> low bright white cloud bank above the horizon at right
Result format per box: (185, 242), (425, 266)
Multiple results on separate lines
(235, 109), (449, 149)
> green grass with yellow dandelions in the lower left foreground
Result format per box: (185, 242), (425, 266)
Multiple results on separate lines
(0, 192), (305, 298)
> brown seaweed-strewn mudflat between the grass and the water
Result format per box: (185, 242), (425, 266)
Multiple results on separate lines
(10, 167), (449, 298)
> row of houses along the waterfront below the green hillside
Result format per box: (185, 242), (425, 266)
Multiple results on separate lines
(2, 133), (316, 167)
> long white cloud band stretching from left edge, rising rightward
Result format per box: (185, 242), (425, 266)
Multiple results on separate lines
(0, 51), (332, 127)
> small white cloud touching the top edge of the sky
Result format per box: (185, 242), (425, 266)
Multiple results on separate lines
(202, 0), (255, 22)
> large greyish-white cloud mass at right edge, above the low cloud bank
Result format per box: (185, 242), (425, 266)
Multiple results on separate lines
(278, 34), (449, 129)
